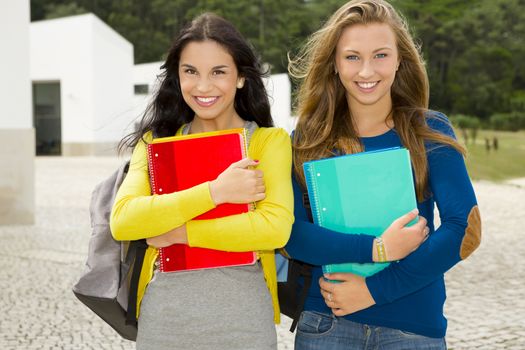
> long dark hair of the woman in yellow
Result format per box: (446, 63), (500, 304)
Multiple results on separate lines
(119, 13), (273, 150)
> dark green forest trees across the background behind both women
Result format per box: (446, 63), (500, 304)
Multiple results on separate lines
(31, 0), (525, 127)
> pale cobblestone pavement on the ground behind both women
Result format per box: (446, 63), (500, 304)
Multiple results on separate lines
(0, 157), (525, 350)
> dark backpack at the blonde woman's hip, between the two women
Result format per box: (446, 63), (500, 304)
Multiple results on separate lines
(275, 192), (313, 333)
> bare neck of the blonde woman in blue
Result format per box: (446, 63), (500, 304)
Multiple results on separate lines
(348, 101), (394, 137)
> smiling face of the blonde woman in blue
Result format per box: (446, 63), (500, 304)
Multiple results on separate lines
(335, 23), (399, 110)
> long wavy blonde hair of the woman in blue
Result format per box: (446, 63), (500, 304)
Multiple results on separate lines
(288, 0), (465, 201)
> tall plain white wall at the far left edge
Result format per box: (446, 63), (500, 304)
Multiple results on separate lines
(0, 0), (35, 225)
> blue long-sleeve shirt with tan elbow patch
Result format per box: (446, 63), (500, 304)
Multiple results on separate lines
(285, 112), (481, 338)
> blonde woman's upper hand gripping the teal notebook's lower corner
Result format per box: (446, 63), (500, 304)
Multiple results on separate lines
(372, 209), (429, 262)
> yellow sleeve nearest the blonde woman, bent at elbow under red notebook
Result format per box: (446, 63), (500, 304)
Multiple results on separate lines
(186, 128), (294, 251)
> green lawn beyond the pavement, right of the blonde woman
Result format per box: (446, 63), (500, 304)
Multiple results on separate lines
(456, 129), (525, 181)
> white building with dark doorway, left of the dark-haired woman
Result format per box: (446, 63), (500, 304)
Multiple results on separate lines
(31, 14), (133, 155)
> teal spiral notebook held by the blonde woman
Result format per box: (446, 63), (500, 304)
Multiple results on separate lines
(303, 147), (417, 276)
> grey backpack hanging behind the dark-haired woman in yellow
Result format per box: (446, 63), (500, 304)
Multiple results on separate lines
(73, 161), (148, 341)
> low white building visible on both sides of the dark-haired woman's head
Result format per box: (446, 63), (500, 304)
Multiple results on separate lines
(133, 62), (295, 132)
